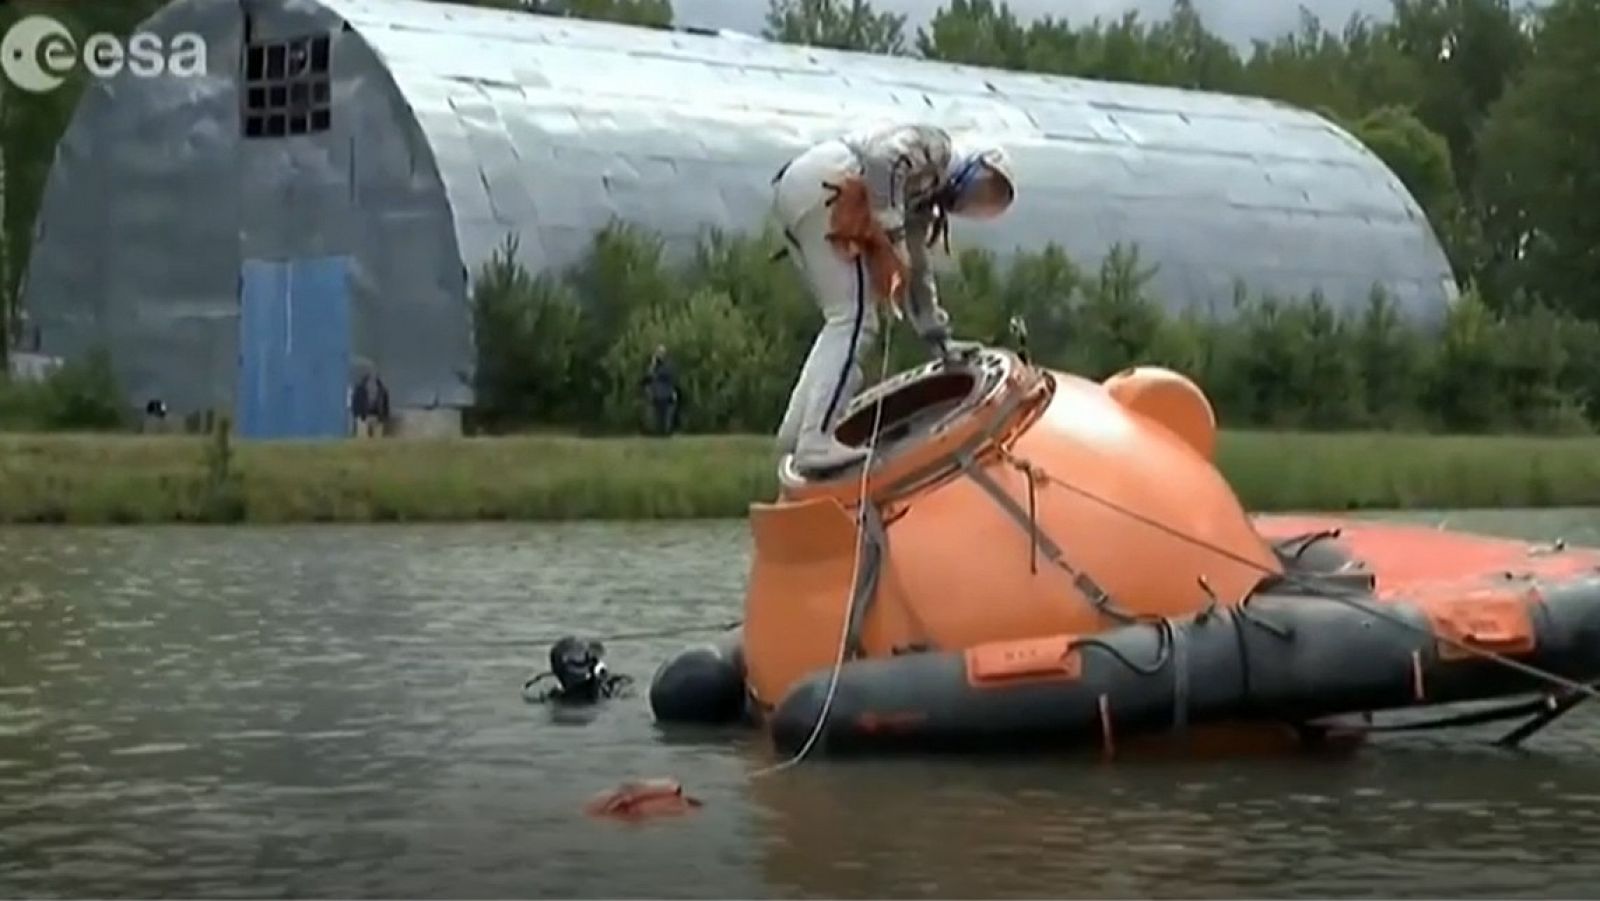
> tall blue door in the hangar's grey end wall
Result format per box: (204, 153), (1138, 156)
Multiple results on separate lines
(237, 256), (350, 438)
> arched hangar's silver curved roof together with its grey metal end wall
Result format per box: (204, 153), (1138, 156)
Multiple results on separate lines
(22, 0), (1453, 422)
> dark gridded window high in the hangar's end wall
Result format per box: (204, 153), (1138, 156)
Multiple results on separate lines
(240, 35), (333, 138)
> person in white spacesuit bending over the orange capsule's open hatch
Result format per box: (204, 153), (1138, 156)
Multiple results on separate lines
(773, 125), (1016, 471)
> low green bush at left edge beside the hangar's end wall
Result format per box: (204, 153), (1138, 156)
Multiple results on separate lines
(0, 350), (130, 430)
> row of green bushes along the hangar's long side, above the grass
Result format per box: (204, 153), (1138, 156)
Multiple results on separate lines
(474, 226), (1600, 434)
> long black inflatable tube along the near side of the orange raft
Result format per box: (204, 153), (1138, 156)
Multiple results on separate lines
(770, 578), (1600, 754)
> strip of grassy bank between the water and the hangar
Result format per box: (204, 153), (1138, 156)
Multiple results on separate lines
(0, 432), (1600, 523)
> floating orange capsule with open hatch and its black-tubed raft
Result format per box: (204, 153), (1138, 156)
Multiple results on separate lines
(650, 349), (1600, 754)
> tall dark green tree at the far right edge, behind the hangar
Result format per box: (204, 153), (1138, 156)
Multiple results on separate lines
(1475, 0), (1600, 318)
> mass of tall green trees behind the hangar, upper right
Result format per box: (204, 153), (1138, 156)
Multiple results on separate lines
(908, 0), (1600, 326)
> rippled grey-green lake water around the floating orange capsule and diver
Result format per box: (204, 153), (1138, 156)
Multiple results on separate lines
(0, 511), (1600, 898)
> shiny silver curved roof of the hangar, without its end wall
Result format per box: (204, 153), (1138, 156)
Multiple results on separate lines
(331, 0), (1454, 318)
